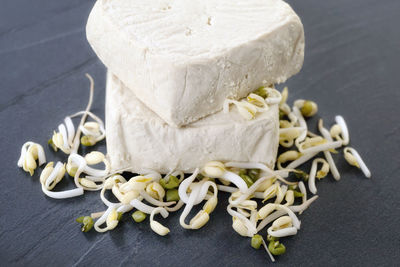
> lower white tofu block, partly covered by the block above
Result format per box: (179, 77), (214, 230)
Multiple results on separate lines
(106, 74), (279, 173)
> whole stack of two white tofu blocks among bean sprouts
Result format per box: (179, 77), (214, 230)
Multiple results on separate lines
(87, 0), (304, 173)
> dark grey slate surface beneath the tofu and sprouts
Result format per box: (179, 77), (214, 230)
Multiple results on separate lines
(0, 0), (400, 266)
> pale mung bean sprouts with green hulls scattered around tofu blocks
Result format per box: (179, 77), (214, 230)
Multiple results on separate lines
(18, 74), (371, 261)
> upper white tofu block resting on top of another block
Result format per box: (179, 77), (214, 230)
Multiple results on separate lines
(86, 0), (304, 126)
